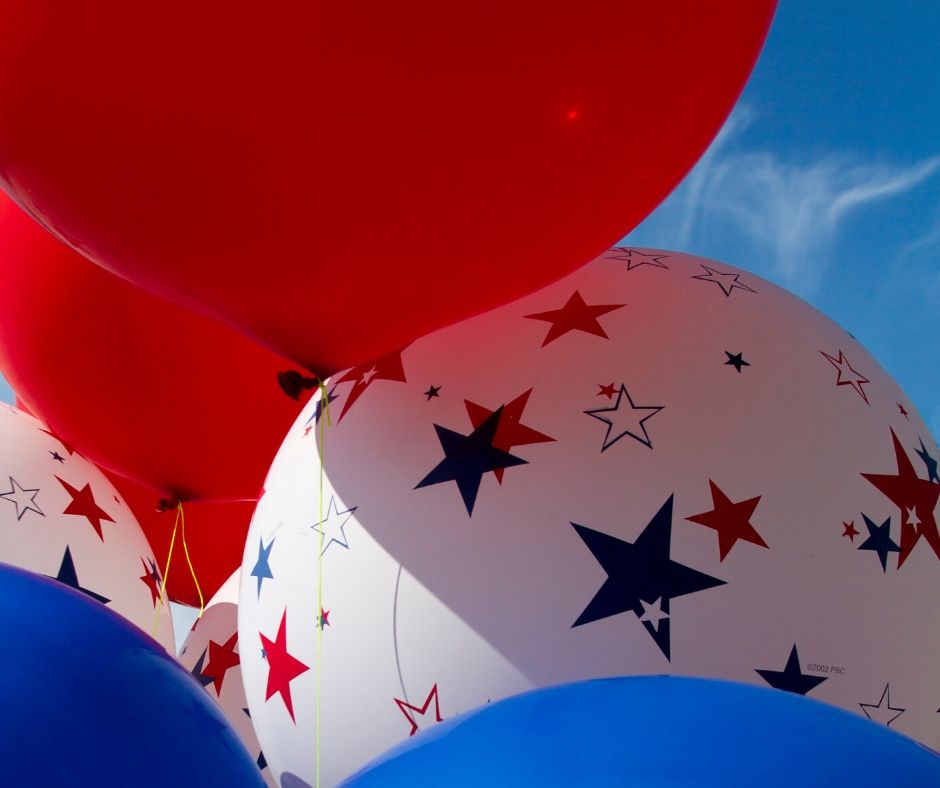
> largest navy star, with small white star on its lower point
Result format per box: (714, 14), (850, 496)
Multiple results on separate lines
(571, 495), (725, 659)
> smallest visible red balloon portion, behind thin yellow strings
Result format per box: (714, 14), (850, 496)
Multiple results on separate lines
(107, 473), (255, 607)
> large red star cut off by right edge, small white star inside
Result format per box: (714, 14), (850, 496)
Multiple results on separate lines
(862, 430), (940, 569)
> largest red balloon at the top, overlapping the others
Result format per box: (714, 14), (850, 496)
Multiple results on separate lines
(0, 0), (775, 374)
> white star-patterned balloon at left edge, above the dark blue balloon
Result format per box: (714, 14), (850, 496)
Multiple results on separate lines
(0, 406), (176, 654)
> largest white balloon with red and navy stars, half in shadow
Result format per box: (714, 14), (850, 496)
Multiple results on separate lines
(235, 249), (940, 785)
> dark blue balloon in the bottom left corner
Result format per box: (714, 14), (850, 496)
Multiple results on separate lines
(0, 564), (265, 788)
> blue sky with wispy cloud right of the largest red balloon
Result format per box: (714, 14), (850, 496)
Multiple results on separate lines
(626, 0), (940, 437)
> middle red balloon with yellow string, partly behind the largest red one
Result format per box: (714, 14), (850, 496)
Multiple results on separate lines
(0, 195), (300, 501)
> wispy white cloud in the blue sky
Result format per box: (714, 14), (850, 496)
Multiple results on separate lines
(624, 106), (940, 294)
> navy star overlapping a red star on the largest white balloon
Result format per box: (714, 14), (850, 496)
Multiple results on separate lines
(415, 407), (527, 516)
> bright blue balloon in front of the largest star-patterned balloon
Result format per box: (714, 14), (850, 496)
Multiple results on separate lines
(344, 676), (940, 788)
